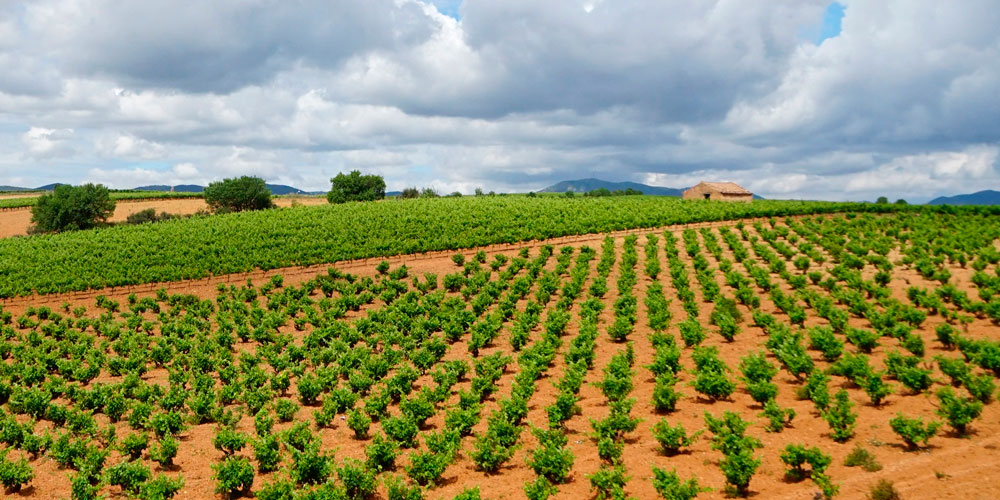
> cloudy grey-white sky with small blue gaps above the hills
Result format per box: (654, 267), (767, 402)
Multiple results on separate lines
(0, 0), (1000, 202)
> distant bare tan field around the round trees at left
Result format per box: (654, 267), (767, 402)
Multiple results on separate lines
(0, 195), (327, 238)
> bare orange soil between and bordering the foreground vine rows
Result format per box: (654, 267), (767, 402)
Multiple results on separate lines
(4, 219), (1000, 500)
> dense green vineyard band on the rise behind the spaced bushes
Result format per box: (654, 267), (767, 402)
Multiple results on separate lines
(0, 196), (960, 297)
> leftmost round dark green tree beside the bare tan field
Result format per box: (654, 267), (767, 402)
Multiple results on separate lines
(31, 184), (115, 232)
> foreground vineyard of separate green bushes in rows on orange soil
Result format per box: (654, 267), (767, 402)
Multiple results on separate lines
(0, 212), (1000, 499)
